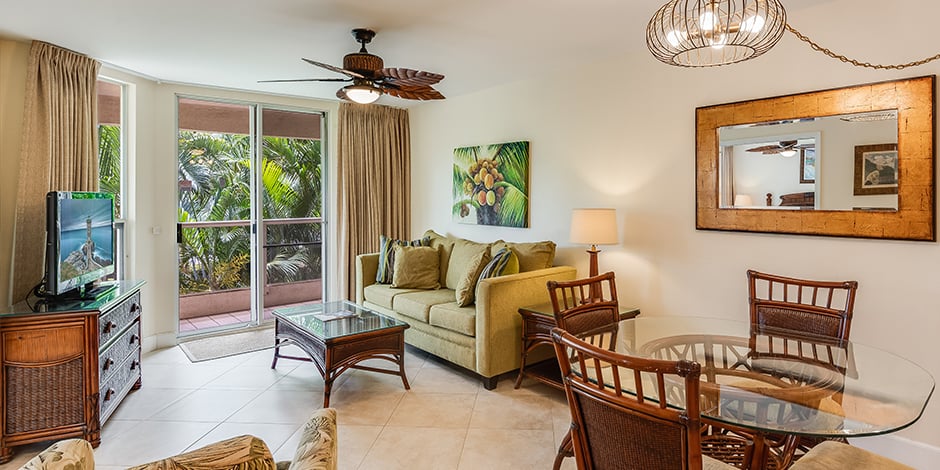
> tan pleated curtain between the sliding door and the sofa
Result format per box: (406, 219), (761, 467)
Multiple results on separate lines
(338, 103), (411, 299)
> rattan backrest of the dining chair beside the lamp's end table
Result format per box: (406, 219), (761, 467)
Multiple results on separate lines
(548, 272), (620, 335)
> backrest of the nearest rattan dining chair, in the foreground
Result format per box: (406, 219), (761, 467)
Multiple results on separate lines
(552, 328), (702, 470)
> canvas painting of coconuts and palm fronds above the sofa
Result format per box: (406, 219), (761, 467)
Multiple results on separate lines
(451, 141), (529, 228)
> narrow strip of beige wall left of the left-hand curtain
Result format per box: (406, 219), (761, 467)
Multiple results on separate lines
(0, 38), (29, 308)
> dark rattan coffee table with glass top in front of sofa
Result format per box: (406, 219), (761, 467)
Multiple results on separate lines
(271, 301), (411, 408)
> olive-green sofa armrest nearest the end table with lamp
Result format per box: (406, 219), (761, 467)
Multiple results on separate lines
(476, 266), (577, 377)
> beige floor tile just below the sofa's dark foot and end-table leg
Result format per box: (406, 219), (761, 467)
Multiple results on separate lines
(470, 392), (554, 431)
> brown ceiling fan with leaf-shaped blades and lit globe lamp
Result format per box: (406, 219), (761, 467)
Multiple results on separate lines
(258, 28), (444, 104)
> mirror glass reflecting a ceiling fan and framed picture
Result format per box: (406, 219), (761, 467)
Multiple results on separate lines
(718, 109), (898, 211)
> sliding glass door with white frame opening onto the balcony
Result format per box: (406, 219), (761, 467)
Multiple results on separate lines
(177, 97), (323, 336)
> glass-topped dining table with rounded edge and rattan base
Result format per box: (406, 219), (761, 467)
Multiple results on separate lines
(560, 316), (935, 468)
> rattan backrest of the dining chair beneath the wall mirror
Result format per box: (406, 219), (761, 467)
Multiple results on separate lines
(747, 270), (858, 341)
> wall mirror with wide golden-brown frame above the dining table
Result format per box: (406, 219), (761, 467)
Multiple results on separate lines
(695, 75), (936, 241)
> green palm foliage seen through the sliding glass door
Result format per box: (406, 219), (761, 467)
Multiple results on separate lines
(178, 131), (322, 293)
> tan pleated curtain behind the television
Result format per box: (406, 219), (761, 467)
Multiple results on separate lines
(12, 41), (100, 302)
